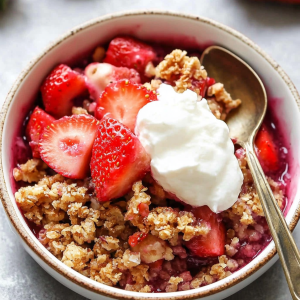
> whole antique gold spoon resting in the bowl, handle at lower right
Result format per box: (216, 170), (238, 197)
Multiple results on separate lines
(201, 46), (300, 300)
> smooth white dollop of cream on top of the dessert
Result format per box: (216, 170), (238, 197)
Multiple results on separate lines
(135, 84), (243, 212)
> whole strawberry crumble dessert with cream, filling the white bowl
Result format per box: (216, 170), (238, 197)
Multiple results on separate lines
(13, 37), (288, 293)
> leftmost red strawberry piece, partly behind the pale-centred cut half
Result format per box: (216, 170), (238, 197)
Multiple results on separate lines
(26, 106), (55, 158)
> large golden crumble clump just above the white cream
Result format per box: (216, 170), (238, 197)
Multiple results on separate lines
(156, 49), (207, 95)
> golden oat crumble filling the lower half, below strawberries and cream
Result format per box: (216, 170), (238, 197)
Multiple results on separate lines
(15, 148), (284, 292)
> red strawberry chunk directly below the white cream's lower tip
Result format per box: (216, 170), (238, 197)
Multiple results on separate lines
(185, 206), (225, 257)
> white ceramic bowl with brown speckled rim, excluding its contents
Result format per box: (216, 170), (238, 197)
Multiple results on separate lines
(0, 11), (300, 300)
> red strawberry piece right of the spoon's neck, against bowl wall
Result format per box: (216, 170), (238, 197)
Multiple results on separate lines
(255, 125), (279, 171)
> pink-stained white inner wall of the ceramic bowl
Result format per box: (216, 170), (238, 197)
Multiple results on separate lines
(2, 13), (300, 299)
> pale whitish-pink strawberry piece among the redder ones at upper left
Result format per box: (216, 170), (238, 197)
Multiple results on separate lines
(85, 63), (141, 101)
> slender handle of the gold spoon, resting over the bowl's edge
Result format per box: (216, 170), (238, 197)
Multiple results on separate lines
(245, 139), (300, 300)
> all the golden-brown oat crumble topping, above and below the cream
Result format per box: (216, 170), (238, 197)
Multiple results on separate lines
(13, 39), (286, 293)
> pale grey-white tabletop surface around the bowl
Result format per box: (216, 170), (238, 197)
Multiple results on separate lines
(0, 0), (300, 300)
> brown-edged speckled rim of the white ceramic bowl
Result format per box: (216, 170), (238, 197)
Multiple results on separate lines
(0, 10), (300, 300)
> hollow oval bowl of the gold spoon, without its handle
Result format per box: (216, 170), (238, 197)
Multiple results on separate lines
(201, 46), (267, 146)
